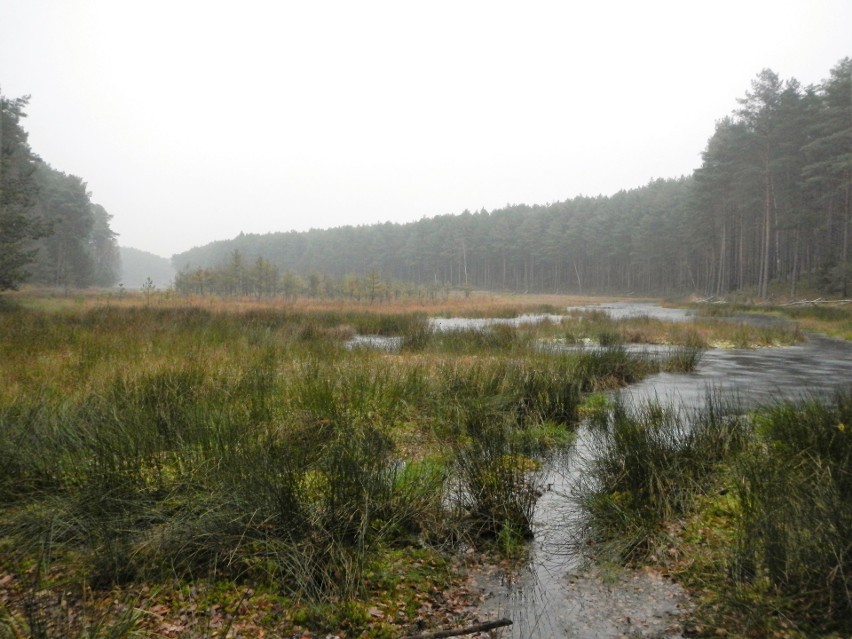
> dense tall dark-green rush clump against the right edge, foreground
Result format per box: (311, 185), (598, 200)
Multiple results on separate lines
(731, 392), (852, 632)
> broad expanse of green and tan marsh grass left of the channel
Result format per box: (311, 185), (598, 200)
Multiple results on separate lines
(0, 298), (692, 636)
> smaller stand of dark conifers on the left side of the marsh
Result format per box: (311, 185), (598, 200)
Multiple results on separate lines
(0, 95), (120, 291)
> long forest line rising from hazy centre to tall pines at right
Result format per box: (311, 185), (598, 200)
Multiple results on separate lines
(173, 58), (852, 298)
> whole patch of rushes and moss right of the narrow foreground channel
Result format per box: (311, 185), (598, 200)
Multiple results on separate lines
(581, 391), (852, 637)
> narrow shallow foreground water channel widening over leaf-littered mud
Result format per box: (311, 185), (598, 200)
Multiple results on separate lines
(476, 440), (690, 639)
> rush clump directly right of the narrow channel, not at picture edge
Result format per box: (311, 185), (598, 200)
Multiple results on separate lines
(579, 393), (746, 564)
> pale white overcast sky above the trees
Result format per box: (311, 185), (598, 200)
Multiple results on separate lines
(0, 0), (852, 257)
